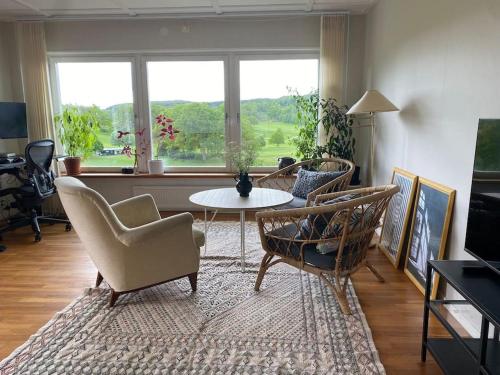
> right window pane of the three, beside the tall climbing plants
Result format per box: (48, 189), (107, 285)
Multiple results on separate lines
(240, 59), (318, 166)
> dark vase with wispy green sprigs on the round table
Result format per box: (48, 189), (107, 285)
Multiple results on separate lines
(226, 143), (257, 197)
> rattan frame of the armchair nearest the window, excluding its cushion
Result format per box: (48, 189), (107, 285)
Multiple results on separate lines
(256, 158), (354, 207)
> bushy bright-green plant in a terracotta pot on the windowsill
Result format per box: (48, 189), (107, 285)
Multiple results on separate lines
(54, 106), (99, 176)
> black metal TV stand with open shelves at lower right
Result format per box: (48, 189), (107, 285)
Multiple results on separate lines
(421, 260), (500, 375)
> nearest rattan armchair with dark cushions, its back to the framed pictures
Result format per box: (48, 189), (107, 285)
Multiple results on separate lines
(255, 185), (399, 314)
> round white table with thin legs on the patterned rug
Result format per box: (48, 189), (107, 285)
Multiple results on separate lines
(189, 187), (293, 272)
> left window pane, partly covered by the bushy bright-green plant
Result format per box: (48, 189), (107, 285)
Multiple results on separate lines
(55, 62), (135, 167)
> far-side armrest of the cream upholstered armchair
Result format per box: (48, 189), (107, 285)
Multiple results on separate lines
(111, 194), (161, 228)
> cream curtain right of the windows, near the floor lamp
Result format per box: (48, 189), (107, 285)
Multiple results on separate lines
(319, 15), (349, 144)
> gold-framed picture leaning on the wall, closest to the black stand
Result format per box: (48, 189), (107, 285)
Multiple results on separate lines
(404, 177), (456, 298)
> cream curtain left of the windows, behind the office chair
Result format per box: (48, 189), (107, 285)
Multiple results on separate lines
(17, 22), (63, 214)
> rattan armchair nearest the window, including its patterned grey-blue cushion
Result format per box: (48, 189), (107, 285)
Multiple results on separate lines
(256, 158), (354, 208)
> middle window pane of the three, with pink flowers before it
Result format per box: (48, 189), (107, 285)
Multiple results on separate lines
(147, 61), (226, 167)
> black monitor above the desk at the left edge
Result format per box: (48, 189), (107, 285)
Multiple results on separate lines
(0, 102), (28, 139)
